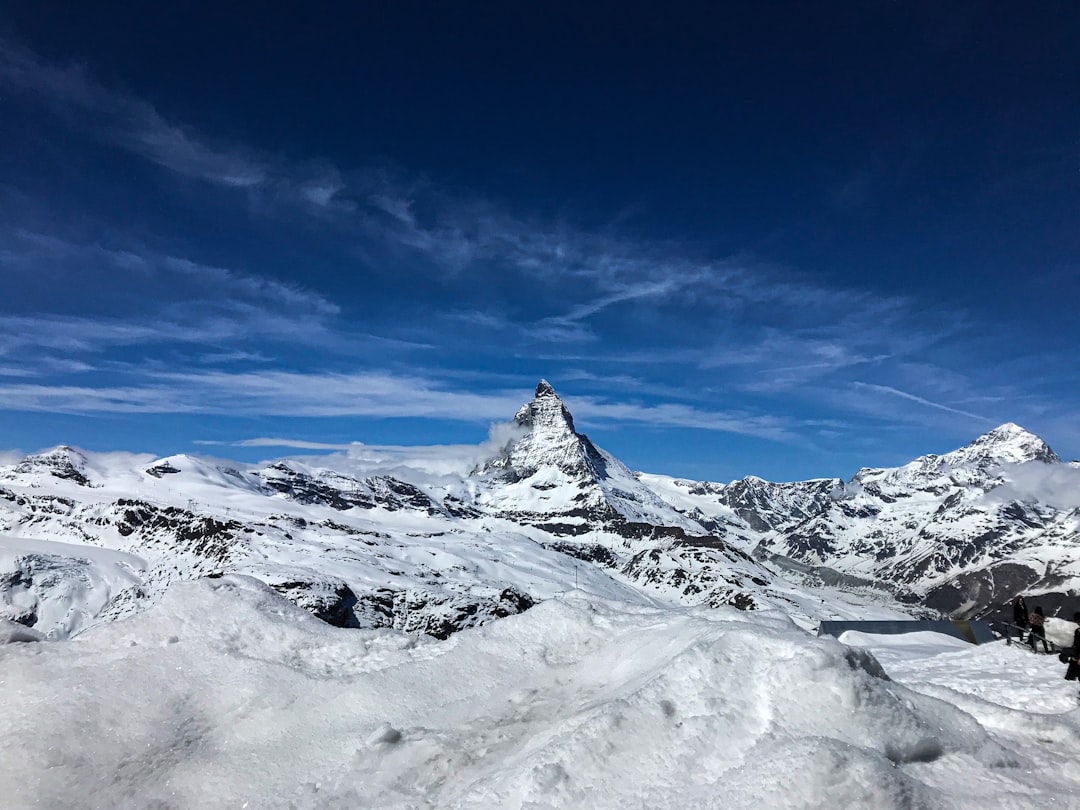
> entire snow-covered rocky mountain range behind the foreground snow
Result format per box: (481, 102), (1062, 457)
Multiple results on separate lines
(0, 381), (1080, 637)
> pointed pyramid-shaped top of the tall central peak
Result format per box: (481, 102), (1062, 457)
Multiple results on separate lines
(481, 380), (607, 480)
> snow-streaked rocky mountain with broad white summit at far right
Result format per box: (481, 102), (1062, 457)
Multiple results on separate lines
(760, 424), (1080, 617)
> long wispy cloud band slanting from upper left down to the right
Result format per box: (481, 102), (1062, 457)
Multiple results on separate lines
(0, 34), (946, 365)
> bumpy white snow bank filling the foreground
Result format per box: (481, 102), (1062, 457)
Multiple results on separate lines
(0, 576), (1080, 810)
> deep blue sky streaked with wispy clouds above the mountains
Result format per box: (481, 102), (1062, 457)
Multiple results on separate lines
(0, 2), (1080, 481)
